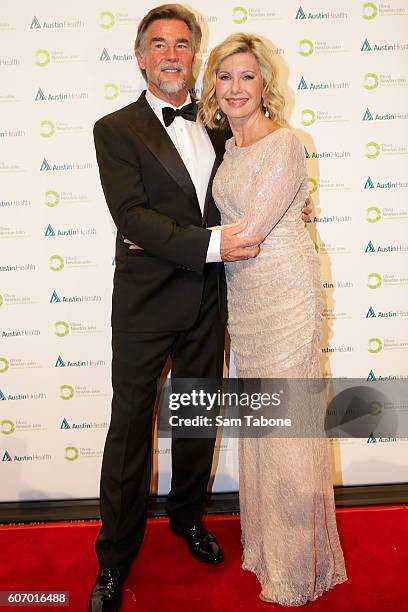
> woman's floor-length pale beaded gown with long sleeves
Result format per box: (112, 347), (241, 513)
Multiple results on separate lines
(213, 128), (347, 606)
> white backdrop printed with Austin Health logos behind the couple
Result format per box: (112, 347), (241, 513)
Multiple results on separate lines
(0, 0), (408, 501)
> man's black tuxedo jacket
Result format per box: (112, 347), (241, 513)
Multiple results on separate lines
(94, 92), (226, 332)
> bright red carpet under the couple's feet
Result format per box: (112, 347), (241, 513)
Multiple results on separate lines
(0, 506), (408, 612)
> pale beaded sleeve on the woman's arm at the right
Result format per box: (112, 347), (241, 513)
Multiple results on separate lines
(242, 129), (306, 238)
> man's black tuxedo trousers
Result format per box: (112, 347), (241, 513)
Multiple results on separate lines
(95, 264), (224, 569)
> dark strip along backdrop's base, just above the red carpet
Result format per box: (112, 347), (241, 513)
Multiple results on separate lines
(0, 483), (408, 524)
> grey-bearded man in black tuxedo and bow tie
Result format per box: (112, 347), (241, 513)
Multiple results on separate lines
(89, 4), (261, 612)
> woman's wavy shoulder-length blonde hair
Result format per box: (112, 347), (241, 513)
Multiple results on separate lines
(199, 32), (285, 129)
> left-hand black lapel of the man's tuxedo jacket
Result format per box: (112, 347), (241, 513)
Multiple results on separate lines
(131, 92), (201, 215)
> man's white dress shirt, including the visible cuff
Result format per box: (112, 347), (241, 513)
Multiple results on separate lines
(146, 90), (221, 263)
